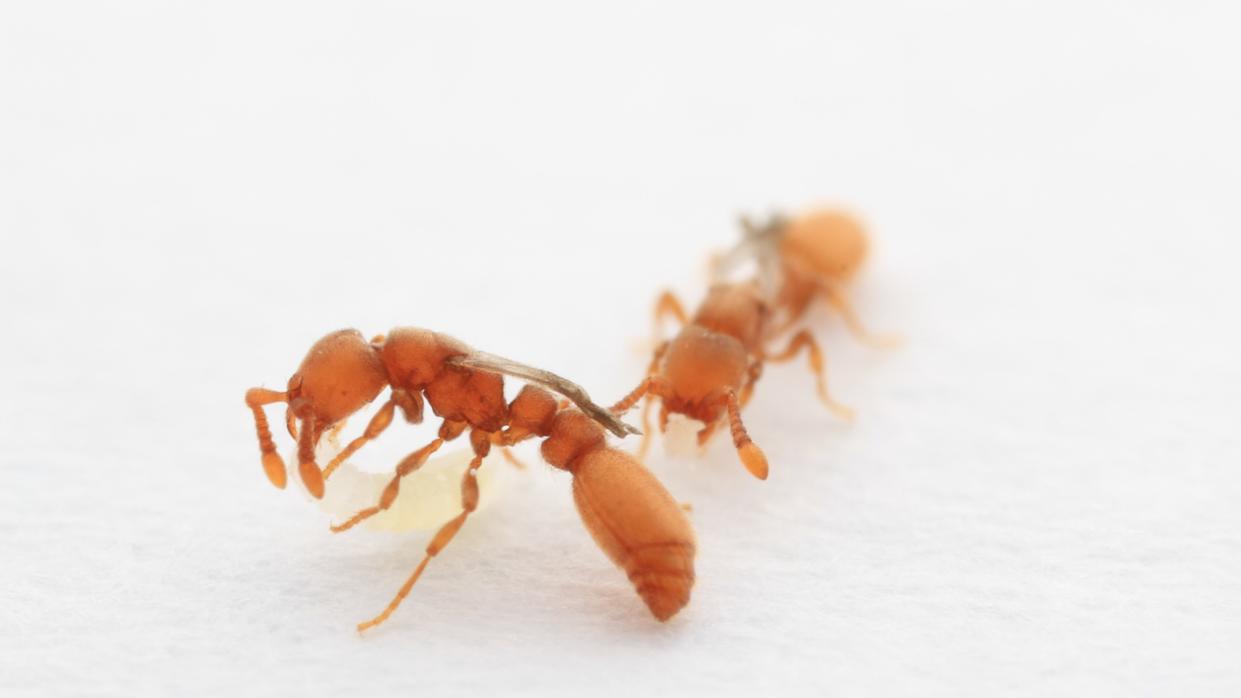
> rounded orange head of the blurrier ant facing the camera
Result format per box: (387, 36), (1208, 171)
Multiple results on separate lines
(664, 325), (747, 402)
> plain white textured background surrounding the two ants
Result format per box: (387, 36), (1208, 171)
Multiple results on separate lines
(0, 1), (1241, 696)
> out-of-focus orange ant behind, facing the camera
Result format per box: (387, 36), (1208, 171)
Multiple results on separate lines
(612, 206), (881, 479)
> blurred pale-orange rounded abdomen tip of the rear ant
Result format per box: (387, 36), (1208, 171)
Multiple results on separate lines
(781, 210), (870, 281)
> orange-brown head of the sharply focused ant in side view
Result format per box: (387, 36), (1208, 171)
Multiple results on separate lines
(289, 329), (387, 426)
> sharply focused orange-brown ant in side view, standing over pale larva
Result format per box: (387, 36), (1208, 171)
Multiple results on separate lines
(246, 328), (695, 631)
